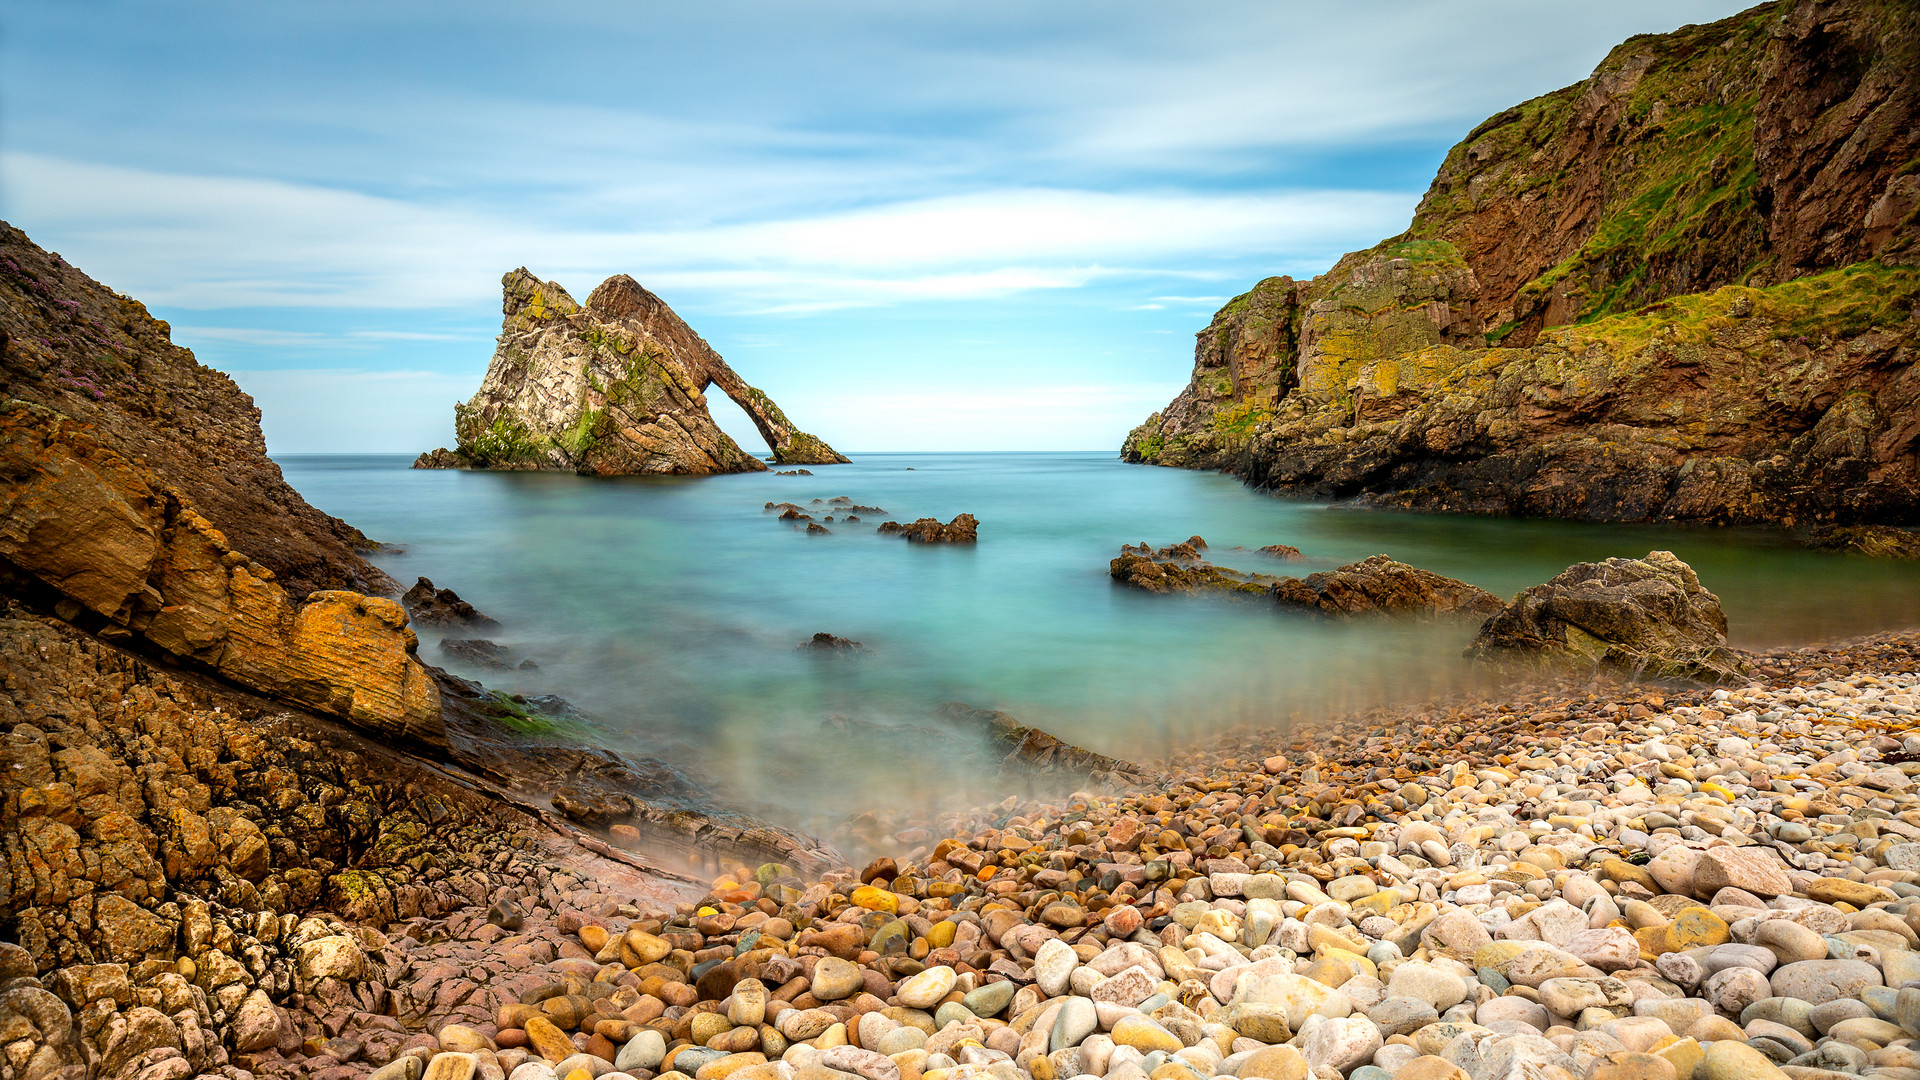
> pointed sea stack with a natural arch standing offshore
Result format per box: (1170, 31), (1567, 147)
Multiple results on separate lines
(415, 267), (847, 477)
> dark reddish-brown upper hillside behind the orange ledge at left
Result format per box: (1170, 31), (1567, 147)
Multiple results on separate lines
(0, 221), (399, 588)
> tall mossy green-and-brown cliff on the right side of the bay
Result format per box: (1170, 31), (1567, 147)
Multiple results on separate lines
(1121, 0), (1920, 523)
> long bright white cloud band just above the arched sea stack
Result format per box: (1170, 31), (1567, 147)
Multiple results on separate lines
(0, 154), (1415, 315)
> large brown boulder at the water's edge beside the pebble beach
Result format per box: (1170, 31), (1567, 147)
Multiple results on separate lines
(1467, 552), (1749, 682)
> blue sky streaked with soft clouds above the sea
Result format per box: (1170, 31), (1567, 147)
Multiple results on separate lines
(0, 0), (1745, 454)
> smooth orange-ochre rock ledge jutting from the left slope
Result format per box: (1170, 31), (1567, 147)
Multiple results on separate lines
(0, 402), (444, 744)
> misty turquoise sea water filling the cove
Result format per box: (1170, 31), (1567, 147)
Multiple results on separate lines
(280, 454), (1920, 826)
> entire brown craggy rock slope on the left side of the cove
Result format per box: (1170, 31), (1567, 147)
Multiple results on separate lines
(0, 220), (864, 1080)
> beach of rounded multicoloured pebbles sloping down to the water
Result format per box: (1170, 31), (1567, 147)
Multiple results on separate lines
(236, 634), (1920, 1080)
